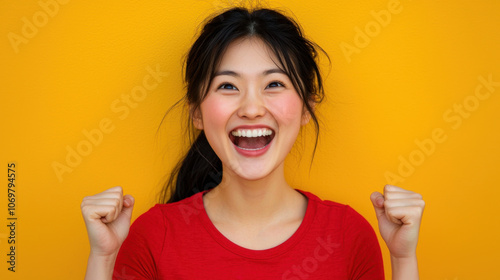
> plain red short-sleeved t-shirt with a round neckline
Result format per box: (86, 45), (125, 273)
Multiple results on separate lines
(113, 190), (384, 280)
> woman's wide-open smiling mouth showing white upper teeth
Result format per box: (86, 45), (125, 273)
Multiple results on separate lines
(229, 128), (275, 151)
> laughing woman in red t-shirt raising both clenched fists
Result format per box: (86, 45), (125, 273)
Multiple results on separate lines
(81, 5), (424, 280)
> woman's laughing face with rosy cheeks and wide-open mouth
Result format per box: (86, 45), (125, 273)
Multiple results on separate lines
(193, 38), (309, 180)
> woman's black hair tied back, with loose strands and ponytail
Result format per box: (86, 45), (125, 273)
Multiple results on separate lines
(159, 7), (329, 203)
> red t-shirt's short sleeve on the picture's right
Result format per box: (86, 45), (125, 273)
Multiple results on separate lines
(344, 206), (385, 280)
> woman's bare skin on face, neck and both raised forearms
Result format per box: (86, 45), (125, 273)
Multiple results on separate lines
(81, 38), (425, 280)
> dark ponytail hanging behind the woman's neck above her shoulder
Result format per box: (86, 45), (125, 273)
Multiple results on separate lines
(159, 131), (222, 204)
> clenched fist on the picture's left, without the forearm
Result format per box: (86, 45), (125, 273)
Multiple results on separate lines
(81, 187), (134, 256)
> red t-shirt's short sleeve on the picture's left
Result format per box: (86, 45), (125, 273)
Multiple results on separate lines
(113, 205), (166, 280)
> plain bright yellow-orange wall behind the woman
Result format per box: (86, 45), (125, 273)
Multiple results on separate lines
(0, 0), (500, 280)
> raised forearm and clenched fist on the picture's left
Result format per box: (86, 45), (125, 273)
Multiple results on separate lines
(81, 187), (134, 280)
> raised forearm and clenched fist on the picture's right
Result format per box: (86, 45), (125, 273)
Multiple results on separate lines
(370, 185), (425, 280)
